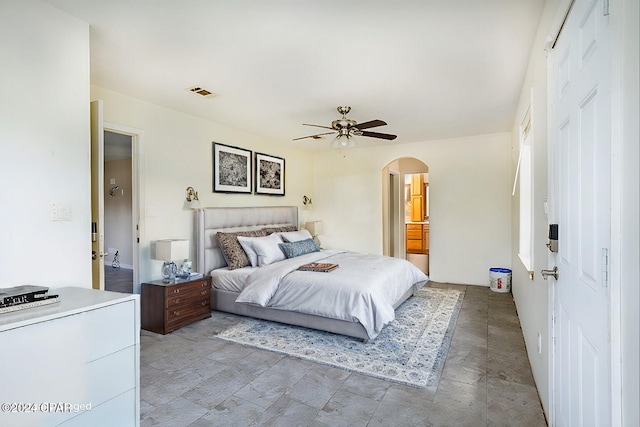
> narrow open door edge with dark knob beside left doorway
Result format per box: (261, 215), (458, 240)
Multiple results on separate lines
(91, 100), (107, 289)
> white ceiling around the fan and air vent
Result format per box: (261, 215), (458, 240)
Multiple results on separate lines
(44, 0), (544, 149)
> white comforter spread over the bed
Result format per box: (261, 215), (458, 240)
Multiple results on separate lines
(236, 251), (428, 339)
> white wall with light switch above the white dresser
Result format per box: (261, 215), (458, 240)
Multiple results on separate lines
(0, 0), (91, 288)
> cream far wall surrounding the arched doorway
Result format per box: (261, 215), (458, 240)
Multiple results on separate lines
(310, 134), (511, 286)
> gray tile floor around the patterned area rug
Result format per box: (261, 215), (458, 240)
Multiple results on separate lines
(140, 283), (546, 427)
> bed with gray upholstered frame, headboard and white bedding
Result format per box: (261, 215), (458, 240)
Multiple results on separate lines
(194, 206), (428, 342)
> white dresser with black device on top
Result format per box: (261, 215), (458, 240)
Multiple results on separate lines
(0, 288), (140, 426)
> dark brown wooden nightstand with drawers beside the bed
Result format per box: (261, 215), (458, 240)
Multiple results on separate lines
(140, 276), (211, 335)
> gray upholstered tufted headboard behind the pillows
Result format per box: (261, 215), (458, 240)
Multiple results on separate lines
(194, 206), (298, 274)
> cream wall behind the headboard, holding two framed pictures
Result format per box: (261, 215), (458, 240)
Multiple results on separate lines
(91, 86), (313, 282)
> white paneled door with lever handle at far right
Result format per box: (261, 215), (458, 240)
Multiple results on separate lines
(550, 0), (611, 426)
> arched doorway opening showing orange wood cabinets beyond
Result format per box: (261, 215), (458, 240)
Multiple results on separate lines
(382, 157), (430, 274)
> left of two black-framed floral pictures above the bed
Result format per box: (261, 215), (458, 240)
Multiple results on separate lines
(213, 142), (252, 194)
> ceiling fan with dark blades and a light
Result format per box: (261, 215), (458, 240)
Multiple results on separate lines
(294, 106), (397, 148)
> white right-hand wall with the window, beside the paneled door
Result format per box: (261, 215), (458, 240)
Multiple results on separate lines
(510, 0), (560, 413)
